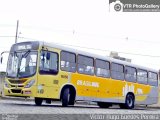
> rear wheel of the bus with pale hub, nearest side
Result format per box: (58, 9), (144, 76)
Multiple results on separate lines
(125, 94), (134, 109)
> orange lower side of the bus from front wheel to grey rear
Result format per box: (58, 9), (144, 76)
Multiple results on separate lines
(71, 73), (158, 104)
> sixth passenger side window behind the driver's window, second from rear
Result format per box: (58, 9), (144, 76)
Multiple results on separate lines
(137, 69), (147, 84)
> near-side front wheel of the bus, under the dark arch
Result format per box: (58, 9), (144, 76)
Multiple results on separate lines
(62, 88), (70, 107)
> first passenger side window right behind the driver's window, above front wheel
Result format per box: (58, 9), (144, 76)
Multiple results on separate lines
(61, 51), (76, 72)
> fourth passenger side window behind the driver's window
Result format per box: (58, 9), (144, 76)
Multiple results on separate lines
(111, 63), (124, 80)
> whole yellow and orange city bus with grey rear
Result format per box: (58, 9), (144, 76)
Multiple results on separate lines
(4, 41), (159, 109)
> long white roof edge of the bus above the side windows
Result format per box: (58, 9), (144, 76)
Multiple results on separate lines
(16, 41), (159, 73)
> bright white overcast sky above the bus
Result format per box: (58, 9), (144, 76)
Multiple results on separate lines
(0, 0), (160, 71)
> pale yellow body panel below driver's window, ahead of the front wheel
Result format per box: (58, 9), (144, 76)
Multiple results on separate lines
(37, 71), (69, 99)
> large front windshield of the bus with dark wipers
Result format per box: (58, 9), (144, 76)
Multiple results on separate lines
(7, 50), (37, 78)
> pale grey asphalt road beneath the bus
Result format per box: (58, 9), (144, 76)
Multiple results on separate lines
(0, 99), (160, 120)
